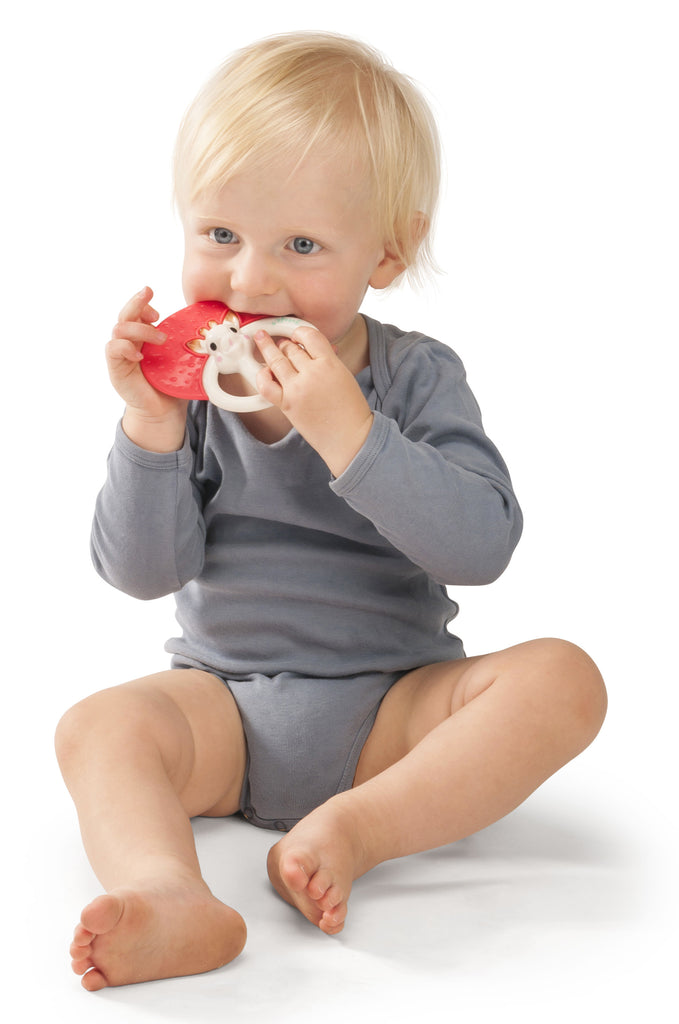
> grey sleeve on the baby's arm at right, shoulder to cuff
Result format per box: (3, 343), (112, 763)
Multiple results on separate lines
(331, 324), (522, 585)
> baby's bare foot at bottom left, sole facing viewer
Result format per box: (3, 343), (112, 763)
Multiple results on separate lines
(71, 881), (246, 992)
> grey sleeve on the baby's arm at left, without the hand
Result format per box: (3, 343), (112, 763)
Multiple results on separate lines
(91, 425), (205, 600)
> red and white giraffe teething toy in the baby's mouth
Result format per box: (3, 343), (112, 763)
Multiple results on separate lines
(141, 301), (310, 413)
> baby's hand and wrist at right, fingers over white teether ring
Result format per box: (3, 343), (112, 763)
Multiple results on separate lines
(255, 327), (373, 476)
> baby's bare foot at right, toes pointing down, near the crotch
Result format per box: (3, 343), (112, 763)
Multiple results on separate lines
(267, 797), (368, 935)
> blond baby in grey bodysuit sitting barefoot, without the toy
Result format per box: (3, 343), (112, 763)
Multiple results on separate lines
(56, 33), (606, 990)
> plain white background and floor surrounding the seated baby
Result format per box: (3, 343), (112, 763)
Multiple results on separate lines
(0, 0), (679, 1022)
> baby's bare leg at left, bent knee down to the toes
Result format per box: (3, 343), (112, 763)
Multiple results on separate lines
(56, 671), (246, 991)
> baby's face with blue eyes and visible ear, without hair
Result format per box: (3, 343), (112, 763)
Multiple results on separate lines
(182, 149), (402, 344)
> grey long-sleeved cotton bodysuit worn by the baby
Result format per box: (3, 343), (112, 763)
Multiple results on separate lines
(92, 317), (521, 829)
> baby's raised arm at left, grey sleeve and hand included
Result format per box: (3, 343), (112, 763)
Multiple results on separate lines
(91, 289), (205, 599)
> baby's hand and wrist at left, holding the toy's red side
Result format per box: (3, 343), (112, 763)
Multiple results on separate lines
(105, 288), (187, 452)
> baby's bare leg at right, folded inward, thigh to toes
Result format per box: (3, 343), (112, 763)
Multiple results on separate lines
(268, 640), (606, 934)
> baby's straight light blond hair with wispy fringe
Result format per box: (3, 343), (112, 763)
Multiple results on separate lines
(174, 32), (440, 280)
